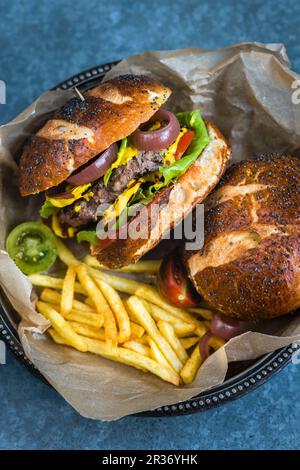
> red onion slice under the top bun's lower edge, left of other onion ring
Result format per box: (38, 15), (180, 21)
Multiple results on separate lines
(66, 143), (118, 185)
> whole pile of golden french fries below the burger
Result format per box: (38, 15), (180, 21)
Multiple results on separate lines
(30, 241), (224, 386)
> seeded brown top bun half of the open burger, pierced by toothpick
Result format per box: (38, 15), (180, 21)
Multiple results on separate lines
(19, 75), (171, 196)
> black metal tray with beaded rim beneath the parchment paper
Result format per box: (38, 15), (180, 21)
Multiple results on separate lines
(0, 61), (300, 417)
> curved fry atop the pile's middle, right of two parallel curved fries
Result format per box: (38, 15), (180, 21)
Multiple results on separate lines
(94, 278), (131, 343)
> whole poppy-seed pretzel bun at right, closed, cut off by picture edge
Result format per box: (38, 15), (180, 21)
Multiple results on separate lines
(183, 155), (300, 320)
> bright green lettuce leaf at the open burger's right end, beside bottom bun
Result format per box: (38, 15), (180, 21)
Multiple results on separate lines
(159, 109), (210, 185)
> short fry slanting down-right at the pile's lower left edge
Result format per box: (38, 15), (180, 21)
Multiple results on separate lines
(36, 301), (88, 352)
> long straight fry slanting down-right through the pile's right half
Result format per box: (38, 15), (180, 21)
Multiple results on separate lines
(125, 296), (182, 372)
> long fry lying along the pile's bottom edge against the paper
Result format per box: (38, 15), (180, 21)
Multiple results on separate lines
(85, 338), (180, 386)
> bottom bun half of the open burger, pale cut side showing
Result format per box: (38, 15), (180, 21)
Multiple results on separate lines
(91, 123), (231, 269)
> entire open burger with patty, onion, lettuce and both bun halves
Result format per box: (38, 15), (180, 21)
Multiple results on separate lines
(19, 75), (231, 268)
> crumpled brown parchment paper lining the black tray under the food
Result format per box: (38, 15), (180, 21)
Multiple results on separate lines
(0, 43), (300, 420)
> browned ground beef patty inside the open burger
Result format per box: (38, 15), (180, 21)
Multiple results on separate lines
(59, 150), (165, 227)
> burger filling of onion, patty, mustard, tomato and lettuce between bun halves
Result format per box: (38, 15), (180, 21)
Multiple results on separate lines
(40, 110), (209, 243)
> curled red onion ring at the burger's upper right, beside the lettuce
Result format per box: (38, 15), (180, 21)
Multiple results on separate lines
(131, 109), (180, 151)
